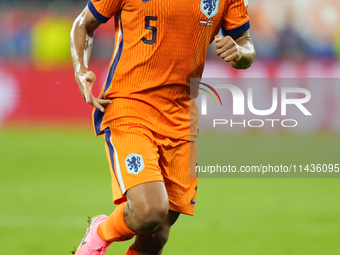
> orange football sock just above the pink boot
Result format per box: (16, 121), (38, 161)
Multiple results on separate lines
(98, 202), (137, 242)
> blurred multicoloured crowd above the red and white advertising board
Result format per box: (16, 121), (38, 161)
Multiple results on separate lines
(0, 0), (340, 62)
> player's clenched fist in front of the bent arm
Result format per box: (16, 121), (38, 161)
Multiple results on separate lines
(215, 35), (244, 63)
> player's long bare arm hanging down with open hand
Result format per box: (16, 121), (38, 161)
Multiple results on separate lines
(70, 6), (111, 112)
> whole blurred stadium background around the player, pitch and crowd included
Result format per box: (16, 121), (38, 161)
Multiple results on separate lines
(0, 0), (340, 255)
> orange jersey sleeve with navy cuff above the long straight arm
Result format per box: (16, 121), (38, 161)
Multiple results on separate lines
(87, 0), (124, 23)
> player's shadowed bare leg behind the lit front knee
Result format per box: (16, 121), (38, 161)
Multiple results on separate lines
(133, 211), (179, 255)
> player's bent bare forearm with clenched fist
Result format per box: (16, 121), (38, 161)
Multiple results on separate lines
(215, 30), (256, 69)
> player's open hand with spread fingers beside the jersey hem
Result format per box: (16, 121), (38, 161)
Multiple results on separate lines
(75, 70), (112, 112)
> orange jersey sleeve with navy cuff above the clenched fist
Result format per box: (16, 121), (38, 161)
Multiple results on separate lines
(222, 0), (250, 37)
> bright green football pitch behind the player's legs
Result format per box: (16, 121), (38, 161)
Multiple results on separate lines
(0, 127), (340, 255)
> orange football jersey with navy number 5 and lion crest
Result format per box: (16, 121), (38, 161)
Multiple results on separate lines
(88, 0), (250, 140)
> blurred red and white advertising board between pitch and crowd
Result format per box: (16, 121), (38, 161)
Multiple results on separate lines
(0, 59), (340, 132)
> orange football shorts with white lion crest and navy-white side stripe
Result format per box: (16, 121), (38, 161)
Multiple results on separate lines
(104, 122), (197, 215)
